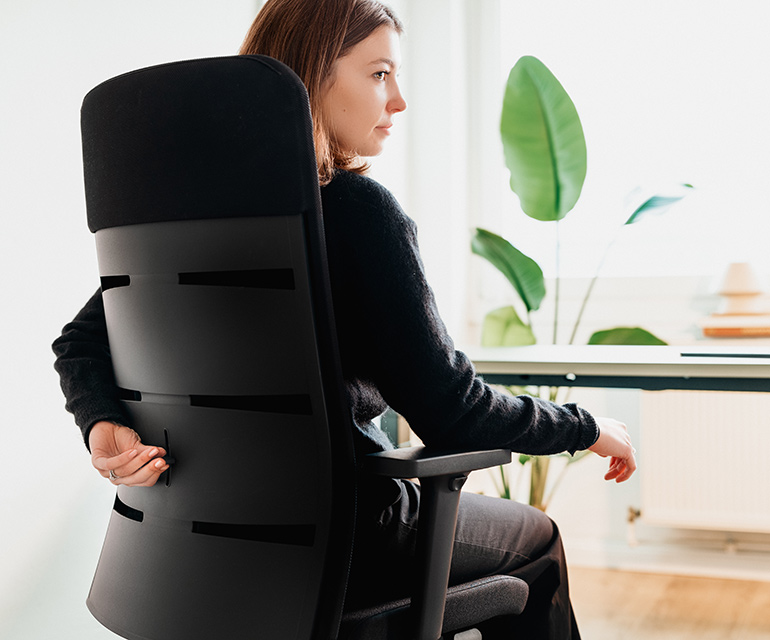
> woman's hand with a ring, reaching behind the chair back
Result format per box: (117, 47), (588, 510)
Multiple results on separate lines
(88, 421), (168, 487)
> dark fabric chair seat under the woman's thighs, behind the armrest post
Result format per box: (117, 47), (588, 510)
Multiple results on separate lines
(339, 576), (529, 640)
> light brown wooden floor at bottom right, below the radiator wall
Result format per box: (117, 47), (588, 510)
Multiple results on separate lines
(570, 567), (770, 640)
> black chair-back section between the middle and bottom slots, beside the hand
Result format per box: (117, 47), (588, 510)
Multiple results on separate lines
(112, 401), (320, 526)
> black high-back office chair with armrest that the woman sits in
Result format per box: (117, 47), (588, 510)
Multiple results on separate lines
(82, 56), (527, 640)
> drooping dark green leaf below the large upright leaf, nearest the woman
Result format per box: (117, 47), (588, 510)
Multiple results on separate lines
(471, 229), (545, 311)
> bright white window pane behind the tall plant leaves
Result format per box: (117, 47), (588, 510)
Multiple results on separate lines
(489, 0), (770, 276)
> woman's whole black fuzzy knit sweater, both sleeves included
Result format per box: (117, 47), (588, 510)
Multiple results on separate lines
(53, 172), (598, 464)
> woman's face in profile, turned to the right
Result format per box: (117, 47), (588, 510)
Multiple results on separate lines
(321, 26), (406, 156)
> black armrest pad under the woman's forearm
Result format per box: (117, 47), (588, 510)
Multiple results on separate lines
(364, 446), (511, 478)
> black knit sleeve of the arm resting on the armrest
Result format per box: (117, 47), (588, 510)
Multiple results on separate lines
(325, 176), (598, 454)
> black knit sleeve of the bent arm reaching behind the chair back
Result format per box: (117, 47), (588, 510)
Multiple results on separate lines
(53, 290), (129, 445)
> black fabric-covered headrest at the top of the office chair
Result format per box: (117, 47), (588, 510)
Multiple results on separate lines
(81, 56), (319, 232)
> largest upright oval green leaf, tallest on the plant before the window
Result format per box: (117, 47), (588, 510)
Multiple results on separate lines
(500, 56), (586, 221)
